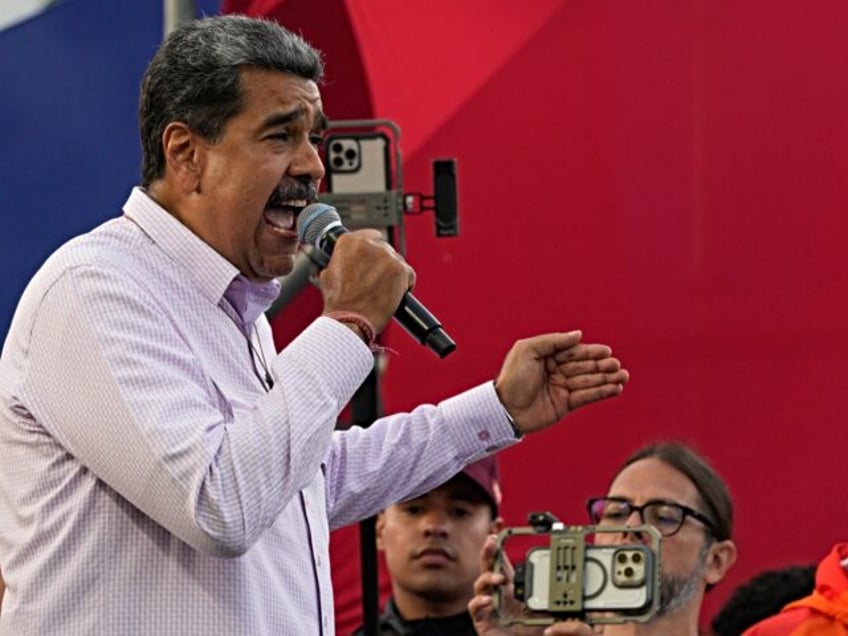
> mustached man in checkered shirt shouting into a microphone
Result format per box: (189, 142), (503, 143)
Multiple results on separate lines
(0, 16), (628, 636)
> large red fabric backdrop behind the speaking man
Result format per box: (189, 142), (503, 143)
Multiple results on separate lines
(225, 0), (848, 634)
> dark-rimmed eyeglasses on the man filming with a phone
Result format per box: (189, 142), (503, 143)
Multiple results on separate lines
(586, 497), (715, 537)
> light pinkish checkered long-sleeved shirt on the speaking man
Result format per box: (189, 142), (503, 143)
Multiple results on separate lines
(0, 189), (514, 636)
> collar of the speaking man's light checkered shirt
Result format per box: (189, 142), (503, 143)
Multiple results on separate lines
(123, 187), (280, 325)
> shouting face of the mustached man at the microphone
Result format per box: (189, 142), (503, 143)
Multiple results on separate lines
(164, 68), (325, 281)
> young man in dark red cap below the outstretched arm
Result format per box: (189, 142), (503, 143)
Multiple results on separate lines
(358, 456), (503, 636)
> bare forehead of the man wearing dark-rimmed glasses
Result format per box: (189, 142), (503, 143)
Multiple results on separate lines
(607, 457), (701, 509)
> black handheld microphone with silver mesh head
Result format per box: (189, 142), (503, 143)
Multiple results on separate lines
(297, 203), (456, 358)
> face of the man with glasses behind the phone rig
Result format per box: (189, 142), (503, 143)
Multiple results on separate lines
(598, 457), (736, 614)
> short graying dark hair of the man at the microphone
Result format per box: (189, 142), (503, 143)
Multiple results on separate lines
(138, 15), (324, 187)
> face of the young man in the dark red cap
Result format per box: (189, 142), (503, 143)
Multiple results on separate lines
(377, 474), (502, 618)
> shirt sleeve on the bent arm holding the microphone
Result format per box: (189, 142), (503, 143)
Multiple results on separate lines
(20, 266), (373, 556)
